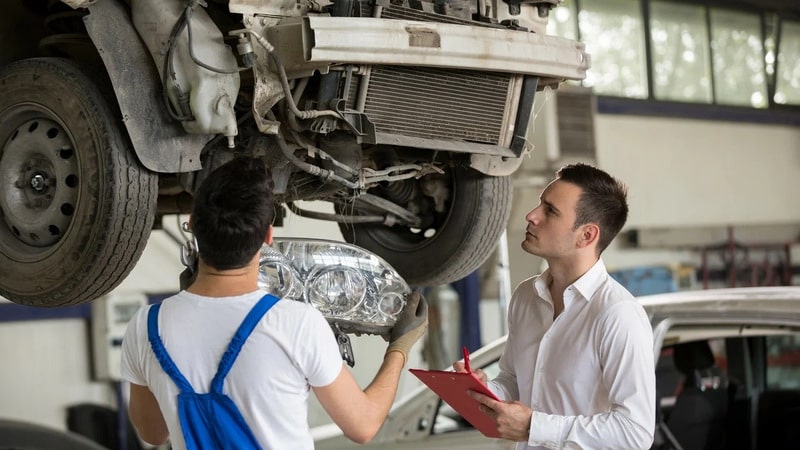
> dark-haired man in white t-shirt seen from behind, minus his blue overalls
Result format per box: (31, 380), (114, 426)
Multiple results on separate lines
(121, 157), (427, 449)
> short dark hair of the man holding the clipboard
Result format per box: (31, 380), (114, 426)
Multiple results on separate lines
(556, 163), (628, 255)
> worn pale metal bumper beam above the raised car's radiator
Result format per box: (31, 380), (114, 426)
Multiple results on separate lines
(267, 16), (591, 81)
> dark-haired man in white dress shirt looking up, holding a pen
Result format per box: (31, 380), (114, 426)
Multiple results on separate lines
(453, 164), (656, 450)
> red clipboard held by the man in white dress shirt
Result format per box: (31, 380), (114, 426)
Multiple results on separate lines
(408, 369), (500, 438)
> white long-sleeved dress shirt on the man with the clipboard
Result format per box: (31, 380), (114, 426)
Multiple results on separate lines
(489, 260), (656, 450)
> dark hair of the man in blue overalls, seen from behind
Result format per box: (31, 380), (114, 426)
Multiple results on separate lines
(192, 157), (275, 270)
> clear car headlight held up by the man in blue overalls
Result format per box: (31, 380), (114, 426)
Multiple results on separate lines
(259, 238), (411, 334)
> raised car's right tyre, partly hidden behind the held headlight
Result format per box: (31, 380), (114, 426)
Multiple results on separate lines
(337, 168), (512, 286)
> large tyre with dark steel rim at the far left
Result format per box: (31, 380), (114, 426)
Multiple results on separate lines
(0, 58), (158, 306)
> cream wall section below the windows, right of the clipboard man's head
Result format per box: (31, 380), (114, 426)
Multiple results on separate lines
(596, 115), (800, 228)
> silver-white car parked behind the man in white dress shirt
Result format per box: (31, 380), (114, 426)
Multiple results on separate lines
(313, 287), (800, 450)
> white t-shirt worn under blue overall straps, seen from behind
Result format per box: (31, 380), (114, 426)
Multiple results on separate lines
(121, 291), (343, 449)
